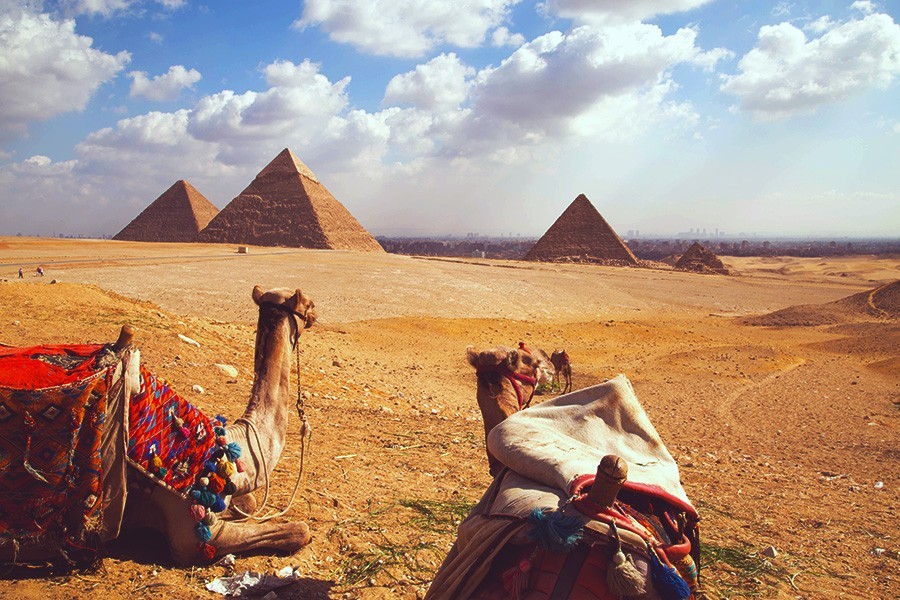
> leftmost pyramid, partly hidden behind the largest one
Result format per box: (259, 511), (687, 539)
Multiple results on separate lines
(113, 179), (219, 242)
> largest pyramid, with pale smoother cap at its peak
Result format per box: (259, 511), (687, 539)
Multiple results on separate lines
(198, 148), (384, 252)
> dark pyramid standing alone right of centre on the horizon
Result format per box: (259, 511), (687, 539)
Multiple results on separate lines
(525, 194), (638, 265)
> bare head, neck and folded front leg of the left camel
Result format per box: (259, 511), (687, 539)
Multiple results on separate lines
(0, 286), (316, 565)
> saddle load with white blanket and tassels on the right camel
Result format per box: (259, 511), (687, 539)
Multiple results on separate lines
(425, 378), (702, 600)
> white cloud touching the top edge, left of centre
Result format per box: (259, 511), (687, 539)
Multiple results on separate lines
(294, 0), (521, 57)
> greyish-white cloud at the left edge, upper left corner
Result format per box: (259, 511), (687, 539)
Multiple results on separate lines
(0, 10), (131, 139)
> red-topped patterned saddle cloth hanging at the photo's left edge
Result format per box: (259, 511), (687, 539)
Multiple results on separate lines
(0, 345), (119, 539)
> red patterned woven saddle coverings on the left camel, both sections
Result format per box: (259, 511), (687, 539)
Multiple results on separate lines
(0, 344), (215, 545)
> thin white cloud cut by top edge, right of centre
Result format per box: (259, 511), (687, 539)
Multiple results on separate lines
(542, 0), (712, 22)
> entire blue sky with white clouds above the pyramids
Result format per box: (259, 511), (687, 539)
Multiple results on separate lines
(0, 0), (900, 238)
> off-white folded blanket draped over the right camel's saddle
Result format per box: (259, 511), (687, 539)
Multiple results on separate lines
(488, 375), (690, 504)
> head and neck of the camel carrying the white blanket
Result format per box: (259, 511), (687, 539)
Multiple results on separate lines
(466, 342), (553, 476)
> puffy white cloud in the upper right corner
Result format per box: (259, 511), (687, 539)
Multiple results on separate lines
(721, 14), (900, 119)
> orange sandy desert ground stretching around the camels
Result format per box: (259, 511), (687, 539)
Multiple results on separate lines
(0, 238), (900, 599)
